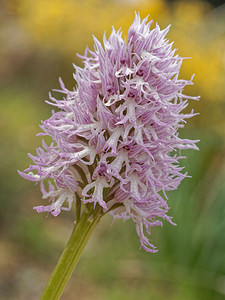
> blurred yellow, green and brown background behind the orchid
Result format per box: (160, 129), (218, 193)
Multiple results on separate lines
(0, 0), (225, 300)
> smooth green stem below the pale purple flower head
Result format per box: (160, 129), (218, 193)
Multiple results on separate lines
(40, 210), (102, 300)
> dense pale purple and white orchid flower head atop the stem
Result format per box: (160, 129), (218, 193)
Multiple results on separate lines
(20, 14), (198, 252)
